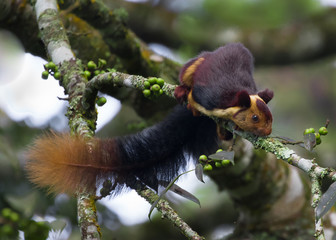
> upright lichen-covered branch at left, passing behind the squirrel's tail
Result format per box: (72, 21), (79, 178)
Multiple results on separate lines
(35, 0), (100, 239)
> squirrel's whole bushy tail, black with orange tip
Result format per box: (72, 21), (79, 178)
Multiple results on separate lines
(26, 106), (217, 194)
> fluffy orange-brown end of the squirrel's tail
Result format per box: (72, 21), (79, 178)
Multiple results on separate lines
(26, 133), (118, 193)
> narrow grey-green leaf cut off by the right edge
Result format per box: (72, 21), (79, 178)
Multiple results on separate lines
(316, 182), (336, 220)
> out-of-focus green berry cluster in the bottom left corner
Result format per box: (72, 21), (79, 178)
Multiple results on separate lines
(0, 208), (50, 240)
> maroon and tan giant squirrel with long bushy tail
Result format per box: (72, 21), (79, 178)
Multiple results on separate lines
(26, 43), (273, 194)
